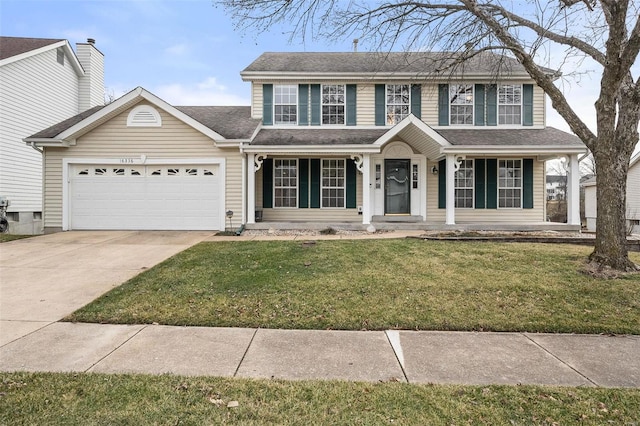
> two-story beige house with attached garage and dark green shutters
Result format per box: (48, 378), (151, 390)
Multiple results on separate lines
(26, 52), (586, 236)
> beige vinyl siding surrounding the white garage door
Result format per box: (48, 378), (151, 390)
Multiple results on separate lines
(44, 102), (242, 228)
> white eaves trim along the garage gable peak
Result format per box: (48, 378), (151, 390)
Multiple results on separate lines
(56, 87), (225, 141)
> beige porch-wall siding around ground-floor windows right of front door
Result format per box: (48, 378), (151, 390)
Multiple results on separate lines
(427, 157), (546, 224)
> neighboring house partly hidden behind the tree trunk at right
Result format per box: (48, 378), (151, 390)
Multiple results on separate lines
(581, 152), (640, 234)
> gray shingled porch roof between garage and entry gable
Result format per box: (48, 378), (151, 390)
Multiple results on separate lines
(251, 128), (388, 146)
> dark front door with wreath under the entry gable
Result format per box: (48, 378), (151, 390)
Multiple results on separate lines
(384, 160), (411, 215)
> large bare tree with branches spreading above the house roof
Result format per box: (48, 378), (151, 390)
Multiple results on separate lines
(221, 0), (640, 271)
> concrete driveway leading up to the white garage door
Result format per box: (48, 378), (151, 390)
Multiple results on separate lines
(0, 231), (213, 346)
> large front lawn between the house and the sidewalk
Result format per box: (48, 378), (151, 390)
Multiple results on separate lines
(66, 239), (640, 334)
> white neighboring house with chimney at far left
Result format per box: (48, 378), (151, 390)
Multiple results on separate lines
(0, 36), (104, 234)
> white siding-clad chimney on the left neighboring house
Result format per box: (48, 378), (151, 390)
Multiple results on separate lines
(76, 38), (104, 112)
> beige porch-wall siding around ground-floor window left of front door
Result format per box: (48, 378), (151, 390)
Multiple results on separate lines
(256, 161), (362, 222)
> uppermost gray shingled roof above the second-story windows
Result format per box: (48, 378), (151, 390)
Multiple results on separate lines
(240, 52), (556, 76)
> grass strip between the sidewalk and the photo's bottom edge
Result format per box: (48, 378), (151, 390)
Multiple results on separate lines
(0, 373), (640, 426)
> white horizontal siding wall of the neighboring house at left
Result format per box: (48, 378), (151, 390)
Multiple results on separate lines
(0, 48), (78, 212)
